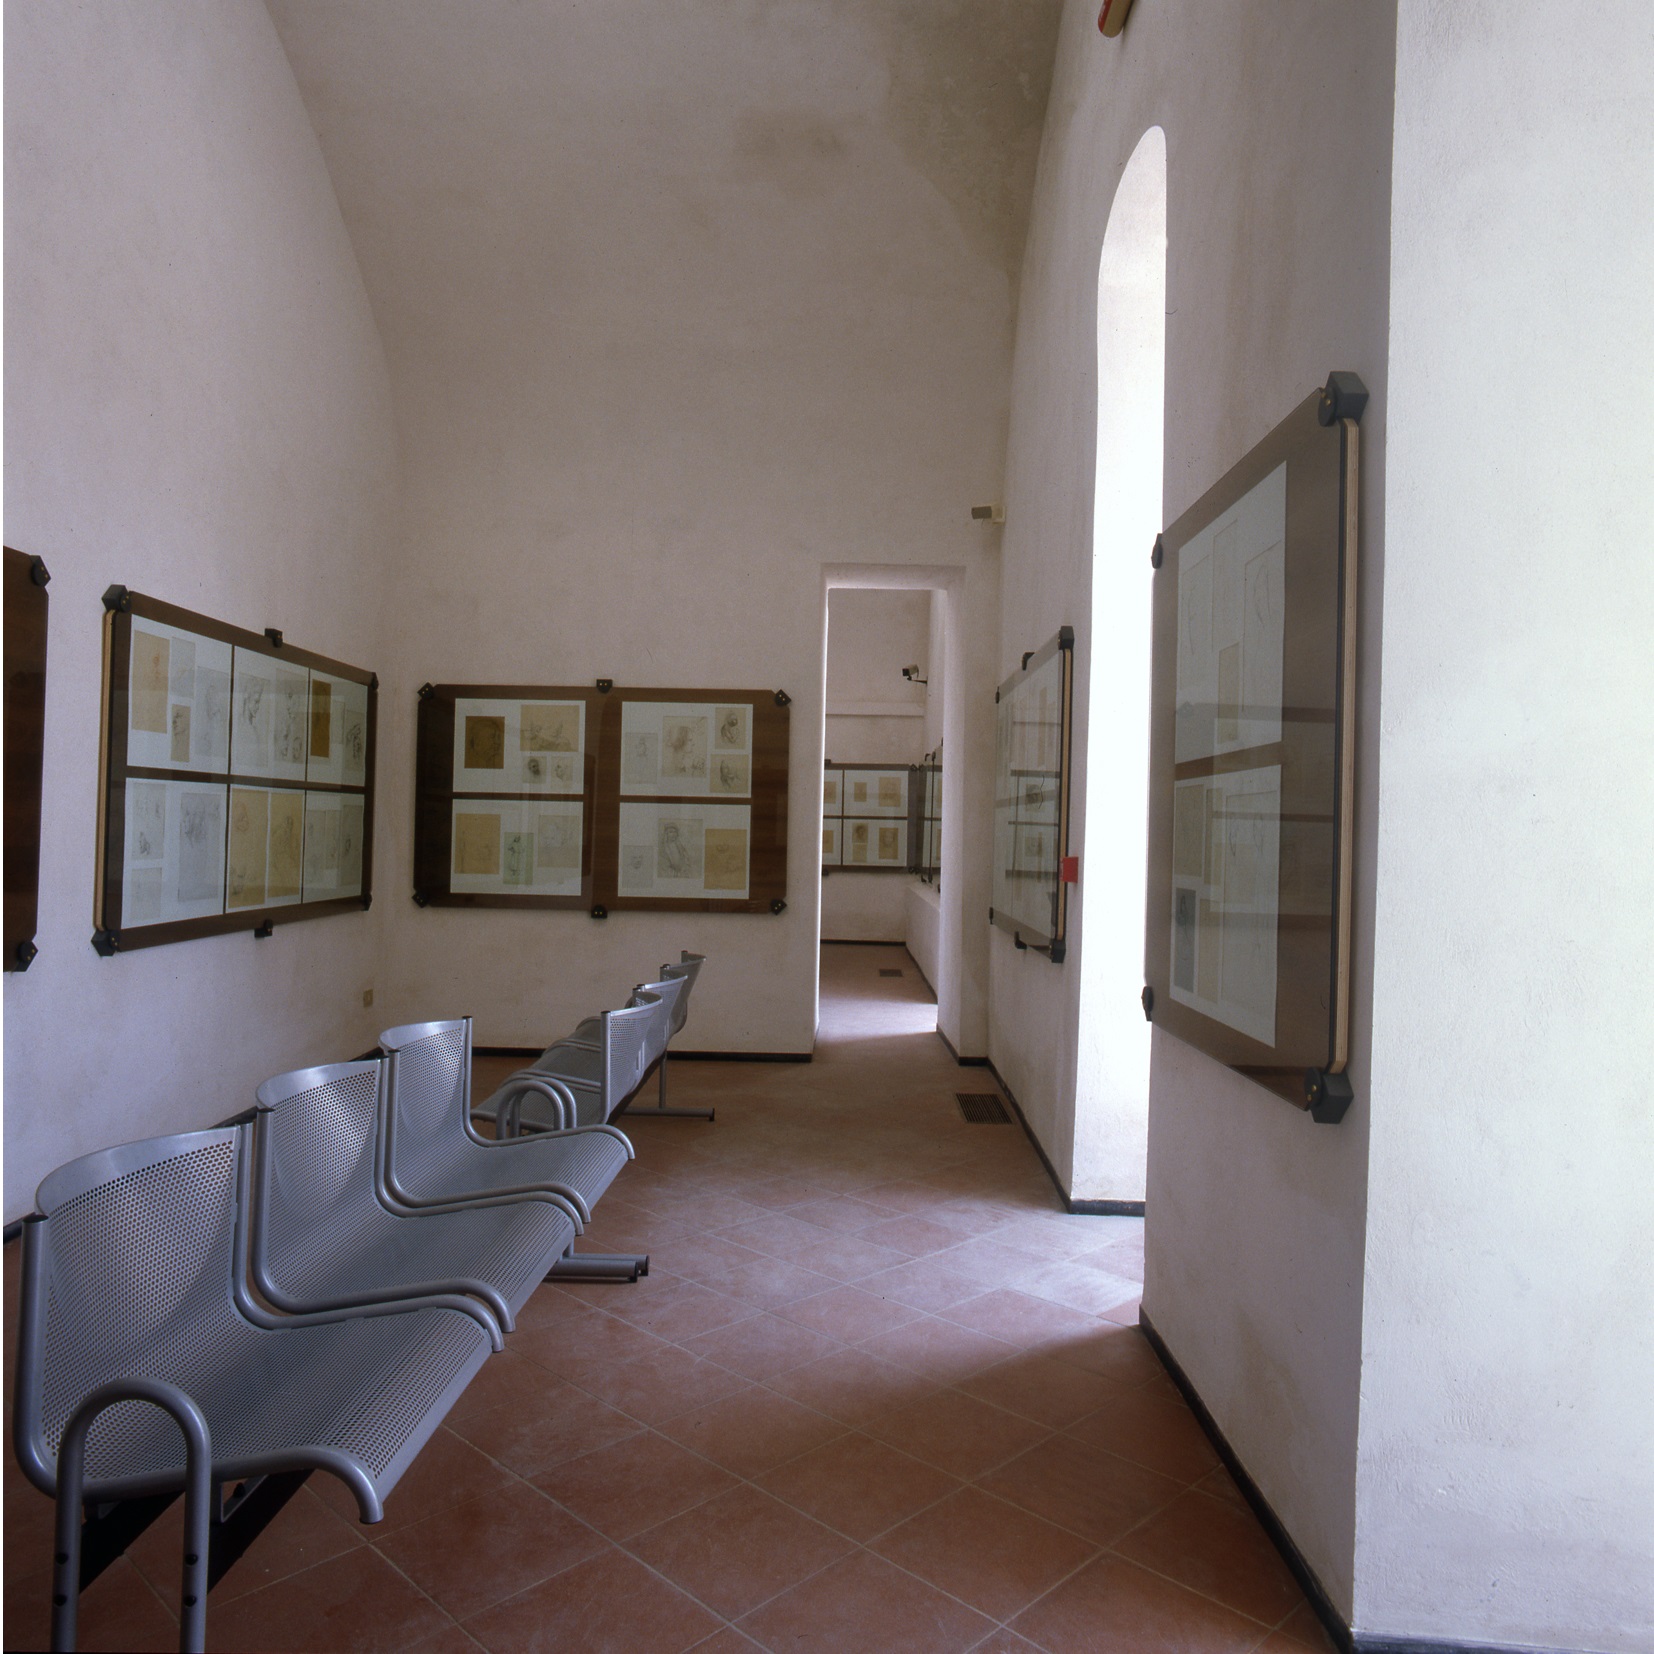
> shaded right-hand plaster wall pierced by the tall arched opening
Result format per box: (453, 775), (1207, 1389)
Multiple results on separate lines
(992, 0), (1394, 1608)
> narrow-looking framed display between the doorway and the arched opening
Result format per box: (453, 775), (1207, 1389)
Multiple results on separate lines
(987, 627), (1073, 964)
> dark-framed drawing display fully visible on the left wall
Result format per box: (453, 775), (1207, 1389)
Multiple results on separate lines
(93, 586), (379, 956)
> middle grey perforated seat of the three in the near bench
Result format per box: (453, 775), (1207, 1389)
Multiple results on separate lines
(251, 1057), (581, 1331)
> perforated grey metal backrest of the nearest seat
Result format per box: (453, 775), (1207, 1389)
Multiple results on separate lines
(15, 1128), (241, 1490)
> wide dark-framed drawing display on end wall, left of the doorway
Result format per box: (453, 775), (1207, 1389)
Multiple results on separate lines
(414, 683), (791, 918)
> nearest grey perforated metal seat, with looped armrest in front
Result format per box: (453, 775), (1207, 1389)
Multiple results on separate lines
(13, 1126), (500, 1647)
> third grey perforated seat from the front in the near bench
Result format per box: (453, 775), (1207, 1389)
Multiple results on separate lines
(377, 1017), (648, 1280)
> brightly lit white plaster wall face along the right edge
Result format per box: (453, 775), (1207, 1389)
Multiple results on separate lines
(1356, 0), (1654, 1651)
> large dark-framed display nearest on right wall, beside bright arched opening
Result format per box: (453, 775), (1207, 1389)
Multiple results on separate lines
(1143, 374), (1366, 1120)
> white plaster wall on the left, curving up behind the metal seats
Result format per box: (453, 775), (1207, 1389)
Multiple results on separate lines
(5, 0), (402, 1219)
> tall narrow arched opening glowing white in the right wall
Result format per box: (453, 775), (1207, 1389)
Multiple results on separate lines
(1073, 126), (1166, 1201)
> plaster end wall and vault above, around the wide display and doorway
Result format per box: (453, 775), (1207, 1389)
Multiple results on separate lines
(271, 0), (1054, 1050)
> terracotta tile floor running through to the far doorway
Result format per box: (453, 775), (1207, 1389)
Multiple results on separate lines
(5, 946), (1330, 1654)
